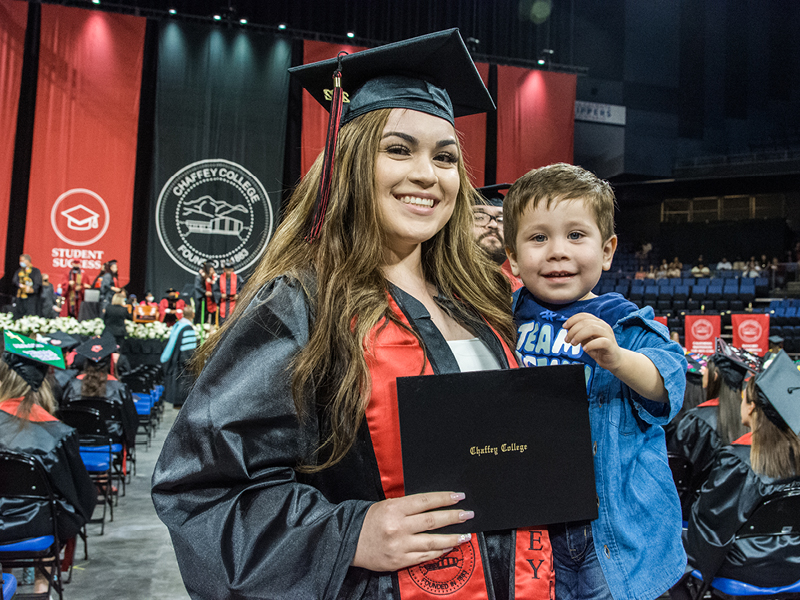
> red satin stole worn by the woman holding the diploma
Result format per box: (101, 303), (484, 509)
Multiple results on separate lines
(365, 296), (555, 600)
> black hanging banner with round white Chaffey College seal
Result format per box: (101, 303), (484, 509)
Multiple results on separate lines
(147, 21), (291, 297)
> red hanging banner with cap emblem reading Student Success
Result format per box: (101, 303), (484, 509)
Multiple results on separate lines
(25, 4), (146, 285)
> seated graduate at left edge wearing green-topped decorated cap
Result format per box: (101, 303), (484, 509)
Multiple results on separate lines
(0, 331), (97, 593)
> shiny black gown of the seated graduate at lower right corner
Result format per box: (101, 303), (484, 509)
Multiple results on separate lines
(685, 444), (800, 586)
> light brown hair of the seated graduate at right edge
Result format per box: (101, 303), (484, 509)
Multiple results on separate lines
(746, 378), (800, 479)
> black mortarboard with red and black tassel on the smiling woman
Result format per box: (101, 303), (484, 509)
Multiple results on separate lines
(289, 29), (495, 241)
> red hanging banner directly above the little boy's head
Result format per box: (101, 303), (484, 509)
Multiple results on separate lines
(497, 66), (578, 181)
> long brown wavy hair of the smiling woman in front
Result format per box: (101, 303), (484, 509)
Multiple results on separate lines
(195, 109), (515, 472)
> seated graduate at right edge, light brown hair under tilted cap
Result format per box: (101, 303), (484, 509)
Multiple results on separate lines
(685, 351), (800, 587)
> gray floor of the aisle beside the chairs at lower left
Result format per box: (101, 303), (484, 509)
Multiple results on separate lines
(18, 405), (189, 600)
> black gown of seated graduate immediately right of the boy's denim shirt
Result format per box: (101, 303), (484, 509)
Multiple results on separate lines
(667, 406), (723, 520)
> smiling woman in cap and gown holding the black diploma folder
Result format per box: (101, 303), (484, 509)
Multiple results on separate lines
(153, 30), (552, 600)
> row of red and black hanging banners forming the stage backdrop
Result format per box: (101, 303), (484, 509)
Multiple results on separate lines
(0, 0), (576, 296)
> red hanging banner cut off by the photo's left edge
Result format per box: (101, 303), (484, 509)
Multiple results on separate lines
(0, 0), (28, 277)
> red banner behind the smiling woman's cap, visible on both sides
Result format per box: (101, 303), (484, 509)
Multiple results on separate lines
(300, 40), (489, 187)
